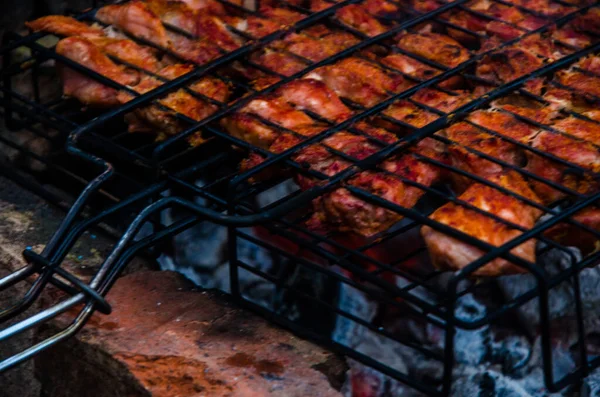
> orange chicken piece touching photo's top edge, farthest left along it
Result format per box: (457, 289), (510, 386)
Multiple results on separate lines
(96, 0), (170, 48)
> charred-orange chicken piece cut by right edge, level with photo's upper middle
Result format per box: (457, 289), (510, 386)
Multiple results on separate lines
(527, 129), (600, 203)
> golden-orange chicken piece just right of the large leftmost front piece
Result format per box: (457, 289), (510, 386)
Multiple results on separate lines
(118, 65), (229, 135)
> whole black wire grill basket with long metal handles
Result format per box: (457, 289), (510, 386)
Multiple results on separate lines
(0, 0), (600, 395)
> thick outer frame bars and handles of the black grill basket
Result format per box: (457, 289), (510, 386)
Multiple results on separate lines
(0, 0), (600, 395)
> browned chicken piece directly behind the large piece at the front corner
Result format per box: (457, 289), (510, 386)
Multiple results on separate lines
(443, 110), (538, 192)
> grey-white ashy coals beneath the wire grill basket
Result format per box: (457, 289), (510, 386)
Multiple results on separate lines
(159, 183), (600, 397)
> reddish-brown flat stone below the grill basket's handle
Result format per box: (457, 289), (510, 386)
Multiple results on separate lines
(35, 271), (347, 397)
